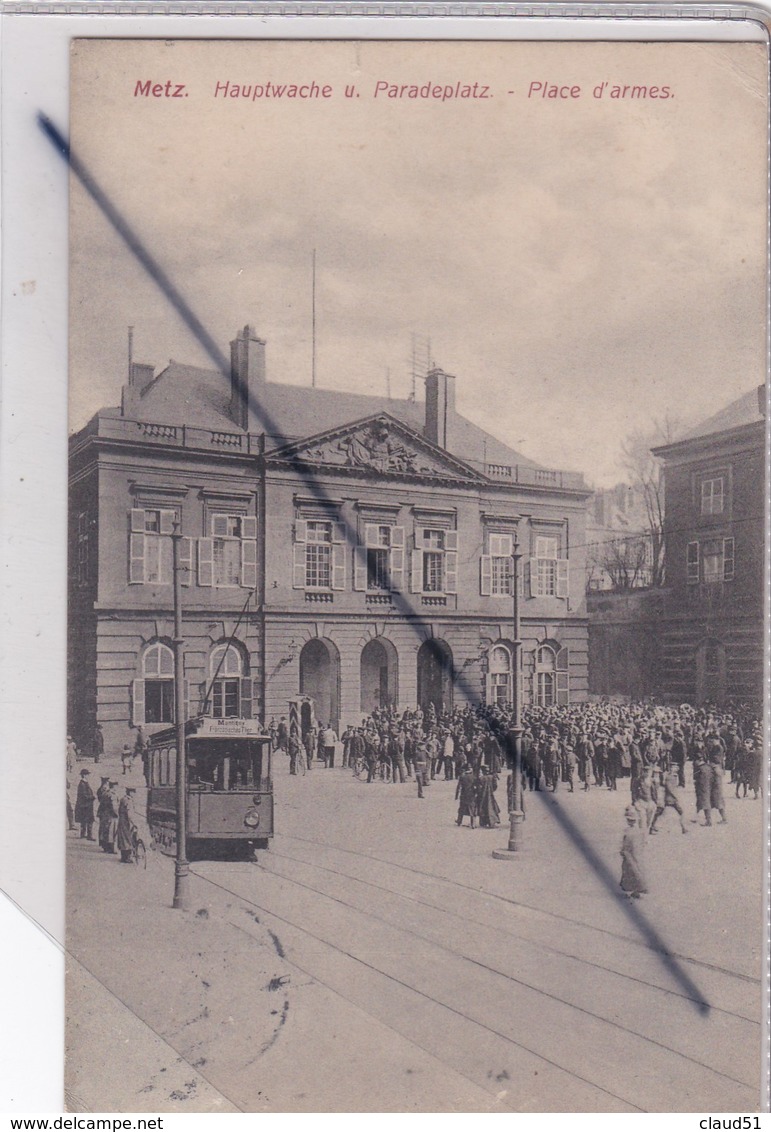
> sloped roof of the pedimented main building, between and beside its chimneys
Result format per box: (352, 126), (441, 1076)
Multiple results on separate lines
(121, 361), (542, 470)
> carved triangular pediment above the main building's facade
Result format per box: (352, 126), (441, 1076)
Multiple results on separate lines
(267, 413), (485, 483)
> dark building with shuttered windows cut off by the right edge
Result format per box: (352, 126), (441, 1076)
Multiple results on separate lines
(653, 386), (768, 703)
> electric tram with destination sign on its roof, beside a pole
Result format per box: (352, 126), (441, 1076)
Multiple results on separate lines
(147, 715), (273, 860)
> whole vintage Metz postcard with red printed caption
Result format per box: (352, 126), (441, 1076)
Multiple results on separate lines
(66, 38), (769, 1113)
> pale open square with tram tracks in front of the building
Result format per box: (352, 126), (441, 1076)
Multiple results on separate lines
(68, 756), (763, 1112)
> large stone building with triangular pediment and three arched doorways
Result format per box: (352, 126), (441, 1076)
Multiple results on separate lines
(69, 327), (589, 749)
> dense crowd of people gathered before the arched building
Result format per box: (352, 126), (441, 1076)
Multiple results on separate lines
(271, 701), (763, 878)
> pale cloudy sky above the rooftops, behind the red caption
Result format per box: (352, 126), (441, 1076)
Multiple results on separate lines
(70, 41), (766, 486)
